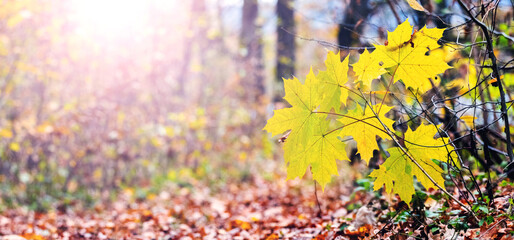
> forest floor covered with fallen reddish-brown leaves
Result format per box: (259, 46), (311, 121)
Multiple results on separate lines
(0, 172), (514, 240)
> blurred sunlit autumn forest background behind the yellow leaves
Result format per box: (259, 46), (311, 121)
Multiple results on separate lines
(0, 0), (512, 214)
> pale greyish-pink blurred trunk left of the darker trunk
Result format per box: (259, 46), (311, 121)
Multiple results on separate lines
(240, 0), (265, 102)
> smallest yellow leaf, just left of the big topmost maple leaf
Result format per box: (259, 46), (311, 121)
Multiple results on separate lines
(352, 49), (387, 86)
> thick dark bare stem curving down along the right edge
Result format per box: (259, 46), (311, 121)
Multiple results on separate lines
(458, 0), (514, 169)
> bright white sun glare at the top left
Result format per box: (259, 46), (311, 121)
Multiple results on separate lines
(71, 0), (150, 37)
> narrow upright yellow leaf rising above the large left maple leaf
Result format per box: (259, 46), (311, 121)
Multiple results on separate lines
(318, 52), (349, 111)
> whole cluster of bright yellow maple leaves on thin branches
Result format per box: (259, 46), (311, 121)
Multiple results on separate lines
(264, 20), (453, 202)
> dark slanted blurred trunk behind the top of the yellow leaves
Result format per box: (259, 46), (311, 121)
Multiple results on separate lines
(337, 0), (371, 57)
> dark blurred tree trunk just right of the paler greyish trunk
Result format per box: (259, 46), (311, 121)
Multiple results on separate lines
(276, 0), (296, 82)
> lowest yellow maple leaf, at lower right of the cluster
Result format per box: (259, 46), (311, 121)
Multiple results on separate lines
(370, 124), (453, 203)
